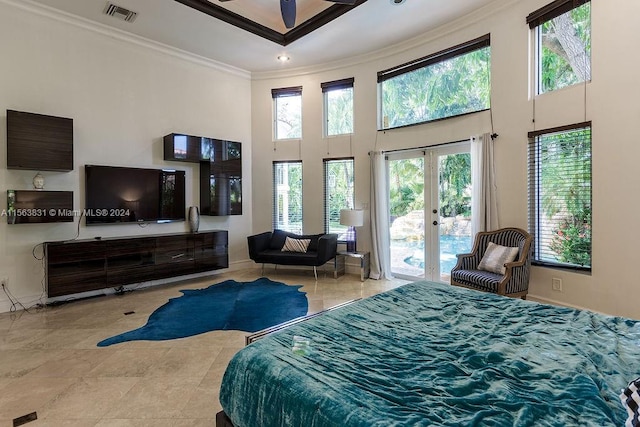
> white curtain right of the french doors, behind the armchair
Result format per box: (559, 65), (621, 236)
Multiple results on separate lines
(471, 133), (499, 236)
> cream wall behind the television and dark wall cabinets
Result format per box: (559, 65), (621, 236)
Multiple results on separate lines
(0, 2), (252, 311)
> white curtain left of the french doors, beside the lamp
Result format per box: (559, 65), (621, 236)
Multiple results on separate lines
(369, 151), (393, 279)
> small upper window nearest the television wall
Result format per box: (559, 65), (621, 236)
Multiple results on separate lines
(271, 86), (302, 140)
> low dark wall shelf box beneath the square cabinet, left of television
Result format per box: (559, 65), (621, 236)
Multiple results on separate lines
(7, 190), (74, 224)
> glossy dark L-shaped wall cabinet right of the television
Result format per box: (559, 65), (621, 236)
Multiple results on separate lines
(163, 133), (242, 216)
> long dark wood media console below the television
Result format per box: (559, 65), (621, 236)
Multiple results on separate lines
(44, 230), (229, 297)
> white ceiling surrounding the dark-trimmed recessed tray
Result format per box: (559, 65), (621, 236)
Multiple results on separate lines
(27, 0), (500, 72)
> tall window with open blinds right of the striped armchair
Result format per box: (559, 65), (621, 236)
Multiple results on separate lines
(529, 122), (591, 270)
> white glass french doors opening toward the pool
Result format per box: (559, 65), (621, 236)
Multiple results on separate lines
(387, 143), (472, 282)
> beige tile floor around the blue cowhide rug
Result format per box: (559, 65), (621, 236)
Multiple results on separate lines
(0, 267), (406, 427)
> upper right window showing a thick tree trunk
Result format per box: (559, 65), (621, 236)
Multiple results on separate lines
(527, 0), (591, 94)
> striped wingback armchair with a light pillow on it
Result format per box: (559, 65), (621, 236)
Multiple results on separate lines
(451, 227), (533, 299)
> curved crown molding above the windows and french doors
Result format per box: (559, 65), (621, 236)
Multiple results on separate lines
(251, 0), (524, 80)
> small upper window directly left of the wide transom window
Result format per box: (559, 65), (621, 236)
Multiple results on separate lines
(320, 78), (354, 136)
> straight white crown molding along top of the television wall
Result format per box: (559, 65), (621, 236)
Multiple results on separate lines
(0, 0), (251, 79)
